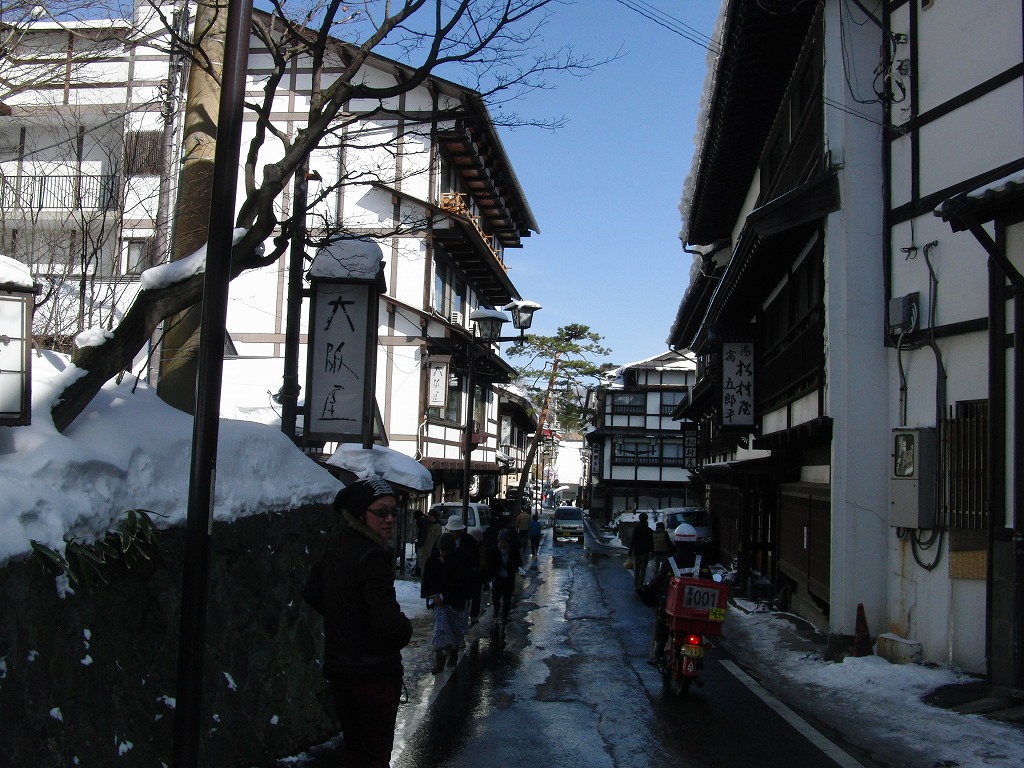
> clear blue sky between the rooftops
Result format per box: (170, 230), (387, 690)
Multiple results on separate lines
(493, 0), (721, 365)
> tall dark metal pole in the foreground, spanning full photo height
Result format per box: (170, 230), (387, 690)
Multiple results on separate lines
(173, 0), (252, 768)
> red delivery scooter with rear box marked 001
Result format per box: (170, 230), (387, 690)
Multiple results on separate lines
(662, 577), (729, 696)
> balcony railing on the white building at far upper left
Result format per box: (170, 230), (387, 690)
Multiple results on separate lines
(0, 174), (118, 211)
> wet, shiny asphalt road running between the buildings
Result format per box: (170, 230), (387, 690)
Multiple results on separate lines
(296, 531), (857, 768)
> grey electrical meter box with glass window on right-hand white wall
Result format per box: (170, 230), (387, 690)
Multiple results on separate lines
(889, 427), (936, 528)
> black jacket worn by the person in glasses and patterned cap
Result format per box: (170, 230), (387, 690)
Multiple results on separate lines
(304, 510), (413, 681)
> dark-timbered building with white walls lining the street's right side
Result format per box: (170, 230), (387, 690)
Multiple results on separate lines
(670, 0), (1024, 686)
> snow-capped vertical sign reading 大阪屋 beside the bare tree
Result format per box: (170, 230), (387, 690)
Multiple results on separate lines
(304, 241), (383, 447)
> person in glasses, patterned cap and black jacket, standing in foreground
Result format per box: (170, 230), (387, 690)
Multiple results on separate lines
(303, 477), (413, 768)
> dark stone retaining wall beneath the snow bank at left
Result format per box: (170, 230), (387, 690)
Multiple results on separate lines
(0, 506), (337, 768)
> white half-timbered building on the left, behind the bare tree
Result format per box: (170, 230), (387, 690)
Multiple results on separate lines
(0, 4), (538, 512)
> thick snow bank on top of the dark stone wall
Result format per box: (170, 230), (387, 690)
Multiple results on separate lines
(0, 351), (342, 564)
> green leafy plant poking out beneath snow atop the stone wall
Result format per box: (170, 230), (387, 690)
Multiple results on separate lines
(32, 509), (160, 589)
